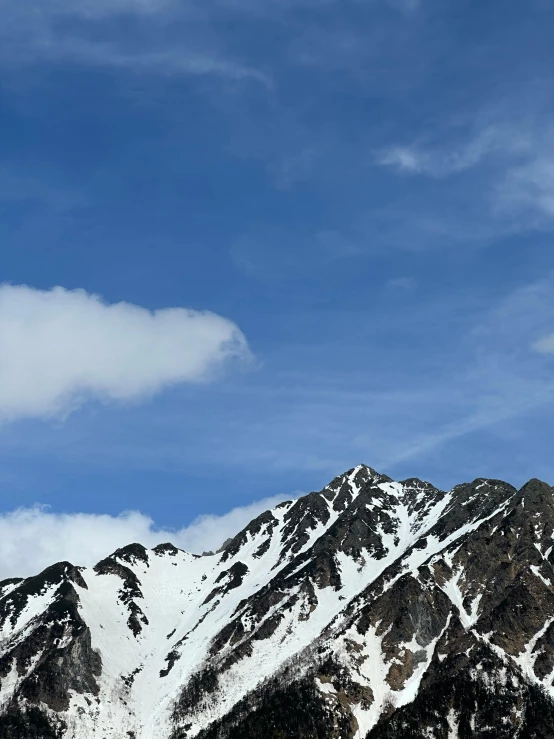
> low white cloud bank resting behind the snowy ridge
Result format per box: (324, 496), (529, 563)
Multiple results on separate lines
(0, 495), (291, 580)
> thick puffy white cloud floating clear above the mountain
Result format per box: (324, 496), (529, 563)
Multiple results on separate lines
(0, 284), (249, 420)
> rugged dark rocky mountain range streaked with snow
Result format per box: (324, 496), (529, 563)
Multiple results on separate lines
(0, 465), (554, 739)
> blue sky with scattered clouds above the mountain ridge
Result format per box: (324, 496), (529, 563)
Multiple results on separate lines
(0, 0), (554, 575)
